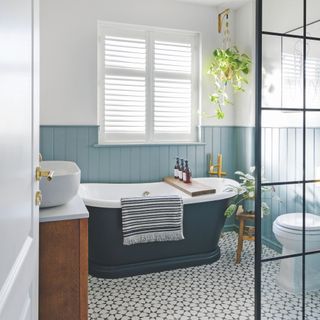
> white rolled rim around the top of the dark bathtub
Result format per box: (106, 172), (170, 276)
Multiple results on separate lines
(78, 177), (239, 208)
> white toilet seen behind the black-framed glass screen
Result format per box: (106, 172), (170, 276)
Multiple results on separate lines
(272, 212), (320, 294)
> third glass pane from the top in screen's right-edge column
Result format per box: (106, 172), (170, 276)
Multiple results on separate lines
(306, 112), (320, 180)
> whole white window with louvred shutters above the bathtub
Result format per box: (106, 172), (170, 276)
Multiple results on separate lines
(98, 22), (200, 143)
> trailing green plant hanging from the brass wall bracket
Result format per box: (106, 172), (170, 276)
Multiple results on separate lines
(208, 47), (251, 119)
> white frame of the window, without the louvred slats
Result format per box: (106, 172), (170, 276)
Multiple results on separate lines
(97, 21), (201, 144)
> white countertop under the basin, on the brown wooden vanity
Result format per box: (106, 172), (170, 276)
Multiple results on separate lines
(39, 195), (89, 222)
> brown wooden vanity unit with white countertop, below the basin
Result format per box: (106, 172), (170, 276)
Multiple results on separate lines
(39, 197), (88, 320)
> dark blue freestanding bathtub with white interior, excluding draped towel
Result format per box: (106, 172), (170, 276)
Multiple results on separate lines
(79, 178), (238, 278)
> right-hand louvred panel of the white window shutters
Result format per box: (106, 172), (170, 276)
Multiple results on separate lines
(154, 40), (192, 140)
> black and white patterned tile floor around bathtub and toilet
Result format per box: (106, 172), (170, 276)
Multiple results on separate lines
(89, 232), (320, 320)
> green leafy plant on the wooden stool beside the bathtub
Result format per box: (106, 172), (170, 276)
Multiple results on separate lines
(224, 167), (280, 217)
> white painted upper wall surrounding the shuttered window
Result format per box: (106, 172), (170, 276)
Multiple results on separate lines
(40, 0), (234, 125)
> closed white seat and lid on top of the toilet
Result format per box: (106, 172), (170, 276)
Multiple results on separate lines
(274, 212), (320, 234)
